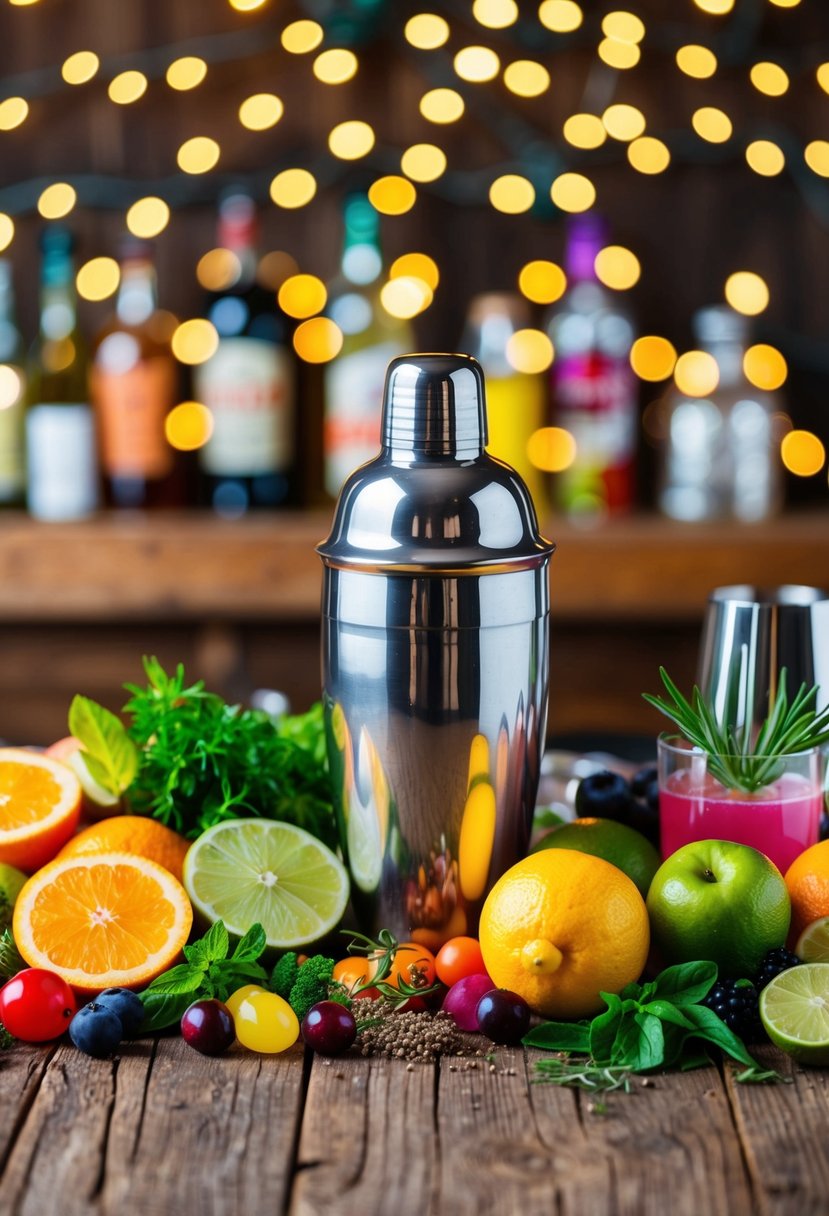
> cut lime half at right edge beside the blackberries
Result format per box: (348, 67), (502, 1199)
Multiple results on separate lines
(760, 963), (829, 1064)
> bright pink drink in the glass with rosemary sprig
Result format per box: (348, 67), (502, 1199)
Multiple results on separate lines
(659, 769), (823, 873)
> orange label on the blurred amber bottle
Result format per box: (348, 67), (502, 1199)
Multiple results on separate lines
(90, 355), (176, 479)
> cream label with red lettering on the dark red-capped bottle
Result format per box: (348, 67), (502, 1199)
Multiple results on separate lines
(196, 338), (294, 477)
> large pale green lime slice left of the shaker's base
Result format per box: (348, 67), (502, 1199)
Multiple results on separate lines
(184, 820), (349, 950)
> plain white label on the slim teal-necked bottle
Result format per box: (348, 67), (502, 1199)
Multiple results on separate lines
(26, 402), (98, 520)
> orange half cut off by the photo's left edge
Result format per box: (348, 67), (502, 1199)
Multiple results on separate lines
(0, 748), (81, 873)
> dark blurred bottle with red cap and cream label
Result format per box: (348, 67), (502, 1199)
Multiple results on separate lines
(193, 192), (297, 517)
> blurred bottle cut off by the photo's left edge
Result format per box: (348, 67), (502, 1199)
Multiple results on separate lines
(0, 259), (26, 507)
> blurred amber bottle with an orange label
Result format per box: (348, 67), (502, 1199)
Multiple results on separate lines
(90, 241), (184, 508)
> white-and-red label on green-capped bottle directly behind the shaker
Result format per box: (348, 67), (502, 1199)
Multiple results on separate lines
(323, 342), (400, 497)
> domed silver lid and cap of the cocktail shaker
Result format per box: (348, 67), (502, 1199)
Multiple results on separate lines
(317, 354), (556, 575)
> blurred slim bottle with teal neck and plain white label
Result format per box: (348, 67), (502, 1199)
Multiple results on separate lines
(26, 225), (98, 520)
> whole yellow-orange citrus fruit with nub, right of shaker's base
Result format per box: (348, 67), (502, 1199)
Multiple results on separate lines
(479, 849), (650, 1018)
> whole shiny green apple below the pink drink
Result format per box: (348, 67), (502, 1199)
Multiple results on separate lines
(648, 840), (791, 979)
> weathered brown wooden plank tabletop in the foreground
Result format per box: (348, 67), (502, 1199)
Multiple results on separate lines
(0, 1037), (829, 1216)
